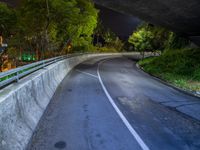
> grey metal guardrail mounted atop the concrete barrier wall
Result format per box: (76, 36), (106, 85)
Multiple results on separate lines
(0, 54), (81, 88)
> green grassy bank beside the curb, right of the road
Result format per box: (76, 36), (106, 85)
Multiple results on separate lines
(139, 48), (200, 91)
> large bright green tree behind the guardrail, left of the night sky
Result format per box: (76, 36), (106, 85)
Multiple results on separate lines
(16, 0), (98, 54)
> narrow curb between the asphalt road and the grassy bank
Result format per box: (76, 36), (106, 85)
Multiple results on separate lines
(136, 63), (200, 98)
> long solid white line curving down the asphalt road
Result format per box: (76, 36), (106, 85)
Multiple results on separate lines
(97, 60), (150, 150)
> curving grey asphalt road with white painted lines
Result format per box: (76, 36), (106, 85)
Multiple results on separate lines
(28, 57), (200, 150)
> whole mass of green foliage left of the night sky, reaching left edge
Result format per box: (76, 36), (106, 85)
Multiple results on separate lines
(0, 0), (98, 58)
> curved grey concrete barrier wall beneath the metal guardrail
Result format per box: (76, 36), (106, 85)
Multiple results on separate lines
(0, 54), (121, 150)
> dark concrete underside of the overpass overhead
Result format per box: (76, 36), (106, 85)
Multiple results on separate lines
(94, 0), (200, 44)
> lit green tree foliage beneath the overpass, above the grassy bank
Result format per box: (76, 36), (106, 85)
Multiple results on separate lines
(129, 23), (189, 51)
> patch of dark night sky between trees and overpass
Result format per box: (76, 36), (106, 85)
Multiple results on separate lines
(96, 6), (141, 39)
